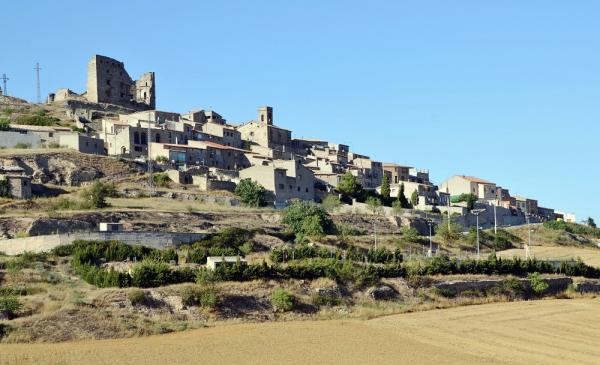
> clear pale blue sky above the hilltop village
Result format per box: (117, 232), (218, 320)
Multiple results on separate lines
(0, 0), (600, 221)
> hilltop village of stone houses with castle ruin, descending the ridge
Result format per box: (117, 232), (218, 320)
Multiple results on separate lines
(0, 55), (575, 227)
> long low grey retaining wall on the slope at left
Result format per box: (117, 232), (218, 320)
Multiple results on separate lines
(0, 232), (207, 255)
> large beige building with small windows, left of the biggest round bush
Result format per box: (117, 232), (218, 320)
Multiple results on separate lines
(240, 160), (315, 206)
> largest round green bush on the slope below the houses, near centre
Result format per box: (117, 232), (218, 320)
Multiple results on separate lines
(282, 200), (333, 242)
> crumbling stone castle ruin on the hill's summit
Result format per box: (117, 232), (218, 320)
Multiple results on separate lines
(48, 55), (156, 111)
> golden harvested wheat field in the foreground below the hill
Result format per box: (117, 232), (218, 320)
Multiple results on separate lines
(0, 299), (600, 365)
